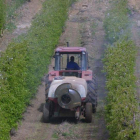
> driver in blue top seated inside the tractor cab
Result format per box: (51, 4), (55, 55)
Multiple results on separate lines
(67, 56), (80, 70)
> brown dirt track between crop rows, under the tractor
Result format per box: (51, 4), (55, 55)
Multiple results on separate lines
(11, 0), (108, 140)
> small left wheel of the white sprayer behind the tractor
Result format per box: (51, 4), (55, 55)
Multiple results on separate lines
(42, 102), (51, 123)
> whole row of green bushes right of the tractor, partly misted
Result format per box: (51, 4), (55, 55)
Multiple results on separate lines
(103, 0), (140, 140)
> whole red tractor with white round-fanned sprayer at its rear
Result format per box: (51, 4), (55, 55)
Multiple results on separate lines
(43, 42), (97, 122)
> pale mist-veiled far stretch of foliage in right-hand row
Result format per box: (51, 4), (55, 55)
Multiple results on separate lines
(104, 0), (128, 43)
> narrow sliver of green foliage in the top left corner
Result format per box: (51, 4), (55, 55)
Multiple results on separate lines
(0, 0), (5, 31)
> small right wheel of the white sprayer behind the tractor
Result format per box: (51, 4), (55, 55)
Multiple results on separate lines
(85, 103), (92, 123)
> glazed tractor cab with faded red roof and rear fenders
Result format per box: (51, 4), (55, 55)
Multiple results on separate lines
(49, 47), (92, 81)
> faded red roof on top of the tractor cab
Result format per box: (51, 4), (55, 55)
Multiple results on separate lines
(55, 47), (86, 52)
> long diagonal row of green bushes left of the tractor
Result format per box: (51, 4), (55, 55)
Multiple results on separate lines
(0, 0), (74, 140)
